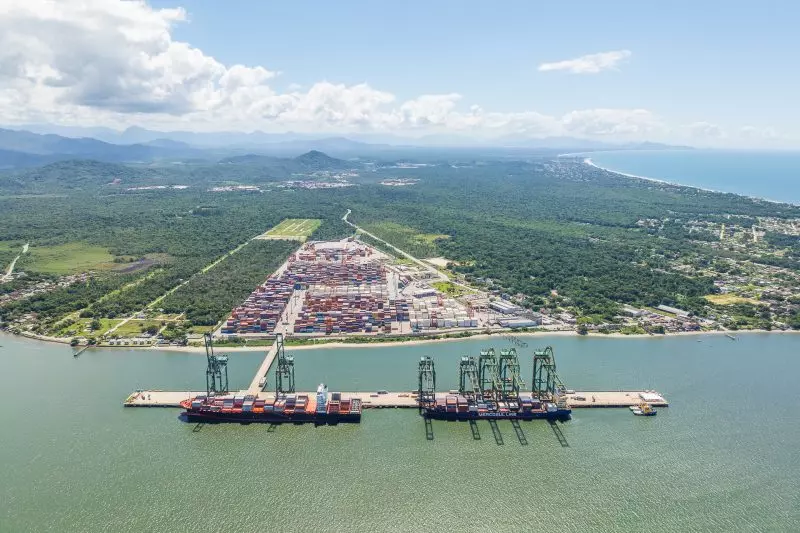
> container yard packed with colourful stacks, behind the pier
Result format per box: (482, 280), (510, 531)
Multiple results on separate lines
(217, 239), (572, 338)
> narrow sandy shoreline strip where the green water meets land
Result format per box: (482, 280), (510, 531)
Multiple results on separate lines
(0, 330), (800, 354)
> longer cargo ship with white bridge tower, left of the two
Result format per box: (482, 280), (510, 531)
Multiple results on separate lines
(181, 385), (362, 424)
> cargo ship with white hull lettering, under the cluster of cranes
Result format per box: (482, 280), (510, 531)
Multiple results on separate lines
(422, 394), (572, 422)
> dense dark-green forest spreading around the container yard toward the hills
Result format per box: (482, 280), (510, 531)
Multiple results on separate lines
(0, 153), (800, 330)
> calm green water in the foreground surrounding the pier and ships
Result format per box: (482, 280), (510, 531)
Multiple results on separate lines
(0, 334), (800, 533)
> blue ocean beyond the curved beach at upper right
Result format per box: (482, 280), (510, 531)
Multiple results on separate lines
(585, 150), (800, 204)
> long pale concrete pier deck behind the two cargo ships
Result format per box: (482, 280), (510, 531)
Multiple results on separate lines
(124, 386), (669, 409)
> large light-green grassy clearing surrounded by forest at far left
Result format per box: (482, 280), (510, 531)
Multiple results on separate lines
(19, 242), (117, 275)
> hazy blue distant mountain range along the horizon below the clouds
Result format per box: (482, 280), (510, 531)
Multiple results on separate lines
(0, 126), (687, 168)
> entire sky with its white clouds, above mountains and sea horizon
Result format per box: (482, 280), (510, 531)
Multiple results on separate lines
(0, 0), (800, 148)
